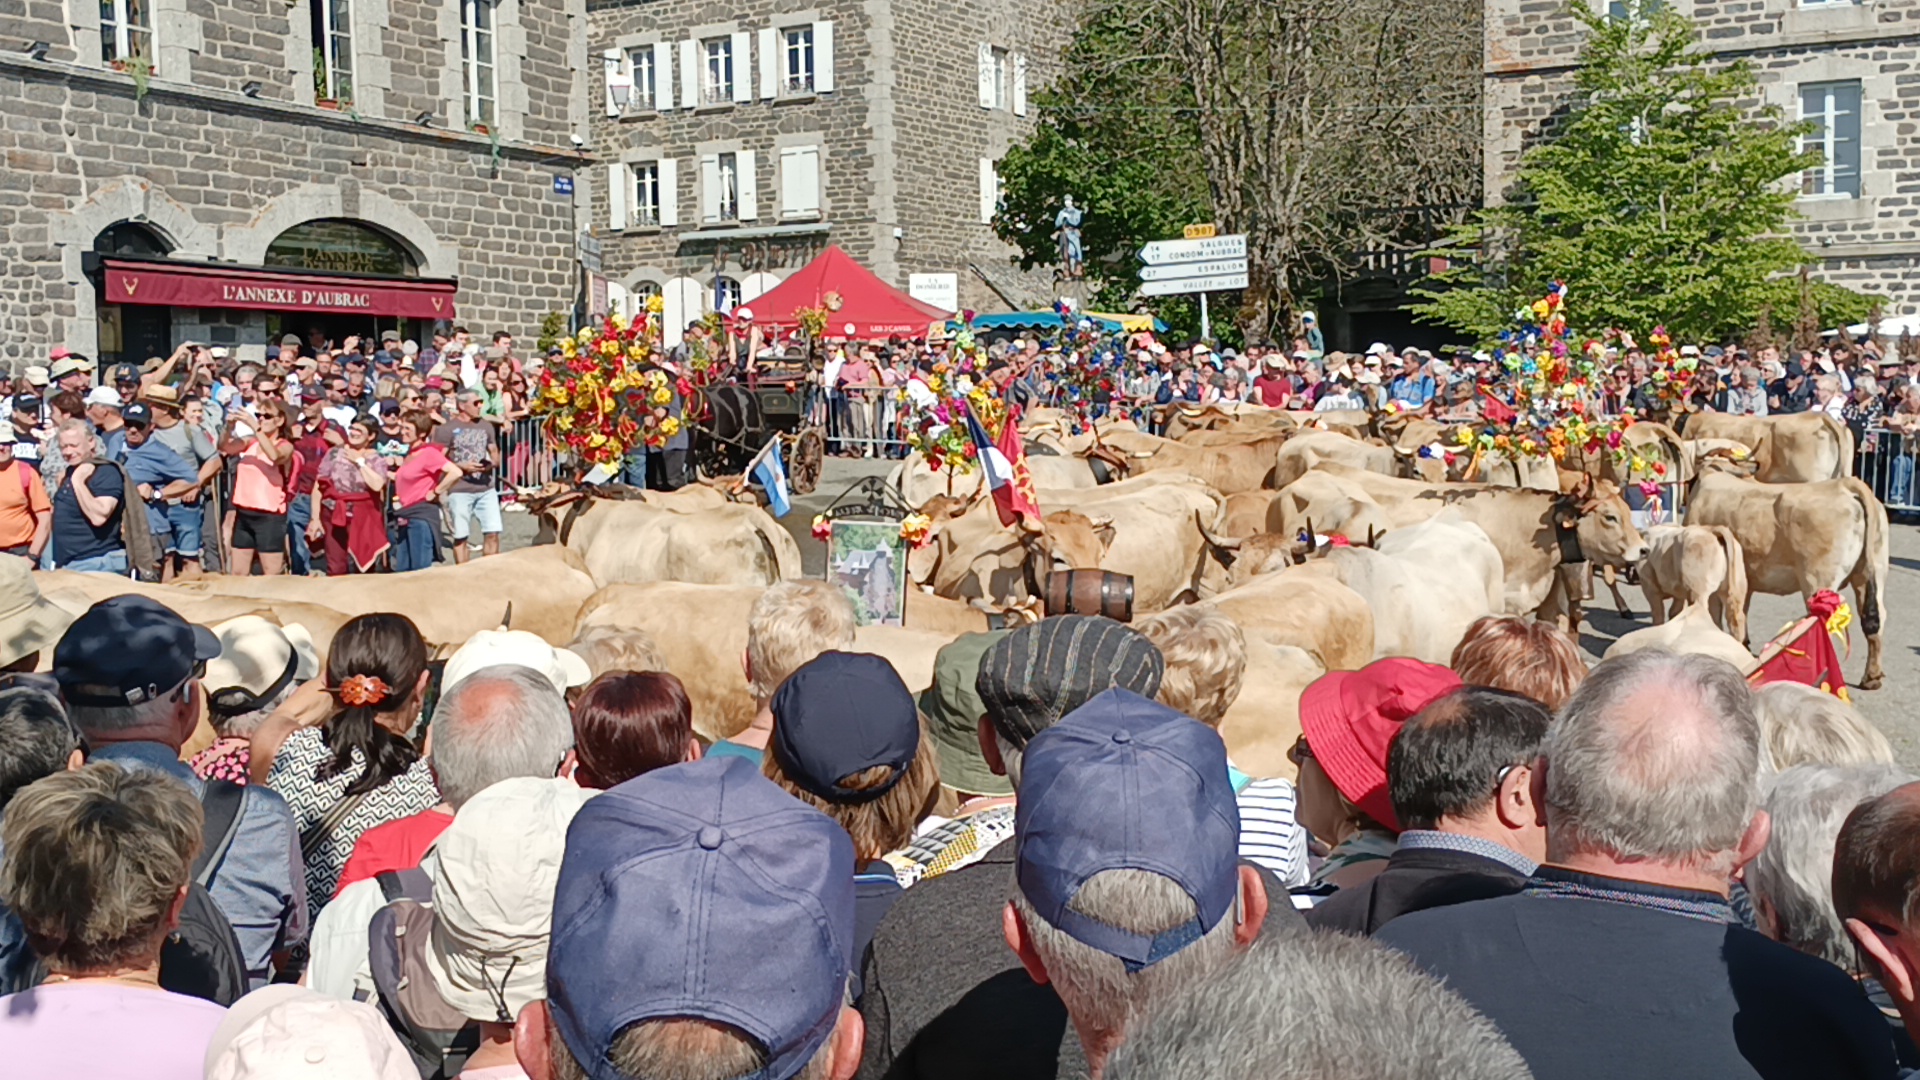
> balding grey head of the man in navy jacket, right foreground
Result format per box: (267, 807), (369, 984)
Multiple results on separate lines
(1540, 651), (1761, 871)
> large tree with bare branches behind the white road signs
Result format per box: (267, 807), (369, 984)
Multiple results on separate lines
(996, 0), (1480, 336)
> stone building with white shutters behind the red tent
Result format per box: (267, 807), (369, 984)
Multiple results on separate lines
(584, 0), (1071, 340)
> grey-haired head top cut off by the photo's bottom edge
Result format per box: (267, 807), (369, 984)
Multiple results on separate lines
(1106, 934), (1530, 1080)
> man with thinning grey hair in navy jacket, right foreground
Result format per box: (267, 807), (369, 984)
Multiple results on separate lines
(1375, 651), (1895, 1080)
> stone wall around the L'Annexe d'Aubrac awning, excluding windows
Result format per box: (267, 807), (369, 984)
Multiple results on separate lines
(0, 0), (588, 361)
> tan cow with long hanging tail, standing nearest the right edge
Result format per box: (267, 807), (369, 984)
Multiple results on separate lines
(1686, 473), (1891, 690)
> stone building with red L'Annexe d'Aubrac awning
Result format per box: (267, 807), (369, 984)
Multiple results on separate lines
(0, 0), (591, 361)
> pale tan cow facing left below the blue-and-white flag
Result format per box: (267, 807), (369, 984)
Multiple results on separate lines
(534, 492), (801, 586)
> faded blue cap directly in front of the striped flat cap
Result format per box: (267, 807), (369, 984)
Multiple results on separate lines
(1014, 690), (1240, 970)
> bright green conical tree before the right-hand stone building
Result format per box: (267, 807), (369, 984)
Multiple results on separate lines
(1415, 0), (1868, 340)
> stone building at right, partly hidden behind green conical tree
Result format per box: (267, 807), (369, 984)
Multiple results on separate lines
(1486, 0), (1920, 313)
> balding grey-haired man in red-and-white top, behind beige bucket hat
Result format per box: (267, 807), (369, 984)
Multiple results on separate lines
(307, 665), (574, 999)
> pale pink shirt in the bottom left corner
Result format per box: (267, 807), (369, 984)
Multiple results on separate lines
(0, 982), (227, 1080)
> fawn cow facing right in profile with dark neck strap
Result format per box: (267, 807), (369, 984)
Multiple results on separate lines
(1267, 463), (1645, 615)
